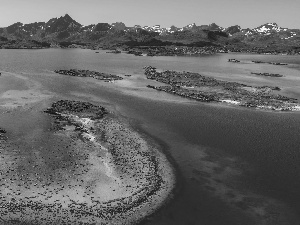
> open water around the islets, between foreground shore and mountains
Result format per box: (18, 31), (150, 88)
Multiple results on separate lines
(0, 49), (300, 225)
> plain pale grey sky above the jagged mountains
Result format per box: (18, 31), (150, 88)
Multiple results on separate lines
(0, 0), (300, 29)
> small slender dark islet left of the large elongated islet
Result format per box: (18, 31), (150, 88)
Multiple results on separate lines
(54, 69), (123, 82)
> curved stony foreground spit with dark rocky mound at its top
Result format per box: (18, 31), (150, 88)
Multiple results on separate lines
(0, 100), (174, 224)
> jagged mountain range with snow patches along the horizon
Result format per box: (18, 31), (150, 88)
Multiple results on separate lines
(0, 14), (300, 53)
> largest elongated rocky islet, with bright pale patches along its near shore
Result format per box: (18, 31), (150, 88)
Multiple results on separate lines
(144, 66), (300, 111)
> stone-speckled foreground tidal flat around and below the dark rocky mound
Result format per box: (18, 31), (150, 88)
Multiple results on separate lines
(0, 74), (175, 224)
